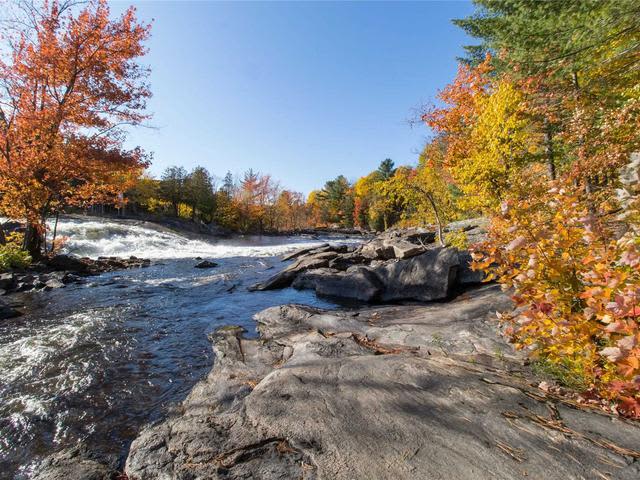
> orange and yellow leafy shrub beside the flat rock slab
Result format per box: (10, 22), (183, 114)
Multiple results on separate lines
(474, 167), (640, 417)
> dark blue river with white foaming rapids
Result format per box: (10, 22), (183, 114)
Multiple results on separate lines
(0, 220), (356, 479)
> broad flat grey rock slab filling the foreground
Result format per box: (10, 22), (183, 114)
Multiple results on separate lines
(126, 287), (640, 480)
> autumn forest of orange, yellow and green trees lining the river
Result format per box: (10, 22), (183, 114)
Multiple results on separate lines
(0, 0), (640, 417)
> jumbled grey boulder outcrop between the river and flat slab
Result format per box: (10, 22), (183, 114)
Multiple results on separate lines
(250, 223), (484, 302)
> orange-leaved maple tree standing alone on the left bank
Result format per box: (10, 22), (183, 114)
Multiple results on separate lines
(0, 0), (151, 257)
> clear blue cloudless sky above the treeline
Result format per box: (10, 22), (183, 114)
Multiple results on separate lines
(112, 1), (472, 194)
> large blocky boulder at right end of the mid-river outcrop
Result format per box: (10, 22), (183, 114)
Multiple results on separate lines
(373, 248), (460, 301)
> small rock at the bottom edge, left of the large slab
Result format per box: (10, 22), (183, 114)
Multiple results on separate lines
(31, 447), (118, 480)
